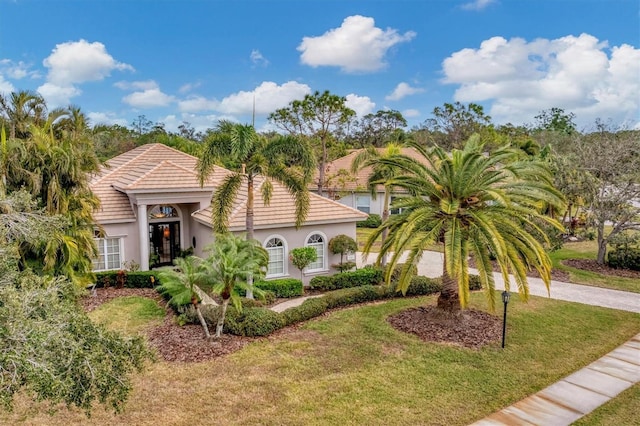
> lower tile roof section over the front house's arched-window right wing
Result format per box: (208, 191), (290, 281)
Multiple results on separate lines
(193, 176), (368, 231)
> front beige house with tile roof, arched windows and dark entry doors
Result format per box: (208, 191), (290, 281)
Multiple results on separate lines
(91, 144), (366, 283)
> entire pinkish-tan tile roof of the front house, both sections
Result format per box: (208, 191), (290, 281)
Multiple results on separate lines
(91, 144), (367, 230)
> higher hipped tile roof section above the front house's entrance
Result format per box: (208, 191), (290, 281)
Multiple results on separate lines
(91, 144), (229, 223)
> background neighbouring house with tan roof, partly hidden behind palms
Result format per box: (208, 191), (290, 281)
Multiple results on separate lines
(318, 148), (424, 216)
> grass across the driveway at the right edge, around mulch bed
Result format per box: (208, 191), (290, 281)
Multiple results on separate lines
(550, 241), (640, 293)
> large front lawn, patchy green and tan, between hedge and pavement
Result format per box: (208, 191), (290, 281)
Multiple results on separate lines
(6, 293), (640, 426)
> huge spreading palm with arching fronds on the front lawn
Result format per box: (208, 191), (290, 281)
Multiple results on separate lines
(365, 135), (564, 312)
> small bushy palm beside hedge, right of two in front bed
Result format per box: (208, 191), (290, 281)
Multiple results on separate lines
(203, 233), (269, 338)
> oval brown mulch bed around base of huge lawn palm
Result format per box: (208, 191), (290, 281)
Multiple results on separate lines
(388, 306), (502, 349)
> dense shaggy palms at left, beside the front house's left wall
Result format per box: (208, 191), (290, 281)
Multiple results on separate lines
(14, 115), (99, 284)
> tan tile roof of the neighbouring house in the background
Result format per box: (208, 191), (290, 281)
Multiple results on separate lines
(312, 148), (424, 191)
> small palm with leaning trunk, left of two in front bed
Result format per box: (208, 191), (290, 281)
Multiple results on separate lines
(158, 256), (211, 339)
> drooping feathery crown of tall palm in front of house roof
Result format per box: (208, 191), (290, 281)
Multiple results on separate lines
(197, 121), (315, 239)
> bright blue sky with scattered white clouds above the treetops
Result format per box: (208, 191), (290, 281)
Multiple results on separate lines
(0, 0), (640, 130)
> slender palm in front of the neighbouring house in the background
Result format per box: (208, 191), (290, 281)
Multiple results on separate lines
(351, 143), (402, 266)
